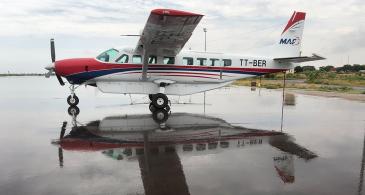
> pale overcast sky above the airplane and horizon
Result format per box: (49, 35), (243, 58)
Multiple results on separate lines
(0, 0), (365, 73)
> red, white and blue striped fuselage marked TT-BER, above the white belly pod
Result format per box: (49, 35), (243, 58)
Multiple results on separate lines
(55, 49), (292, 84)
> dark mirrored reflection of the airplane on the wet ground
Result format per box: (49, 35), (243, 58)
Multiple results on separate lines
(52, 106), (317, 194)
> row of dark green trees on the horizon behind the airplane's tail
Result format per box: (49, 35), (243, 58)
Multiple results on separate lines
(294, 64), (365, 73)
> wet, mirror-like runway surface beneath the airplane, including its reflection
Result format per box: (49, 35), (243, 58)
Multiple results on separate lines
(0, 77), (365, 195)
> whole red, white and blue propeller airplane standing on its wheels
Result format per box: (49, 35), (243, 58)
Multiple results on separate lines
(45, 9), (325, 111)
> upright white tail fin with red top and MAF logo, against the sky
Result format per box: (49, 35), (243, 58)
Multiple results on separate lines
(278, 11), (305, 57)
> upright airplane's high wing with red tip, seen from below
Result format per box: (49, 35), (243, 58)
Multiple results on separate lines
(135, 9), (203, 56)
